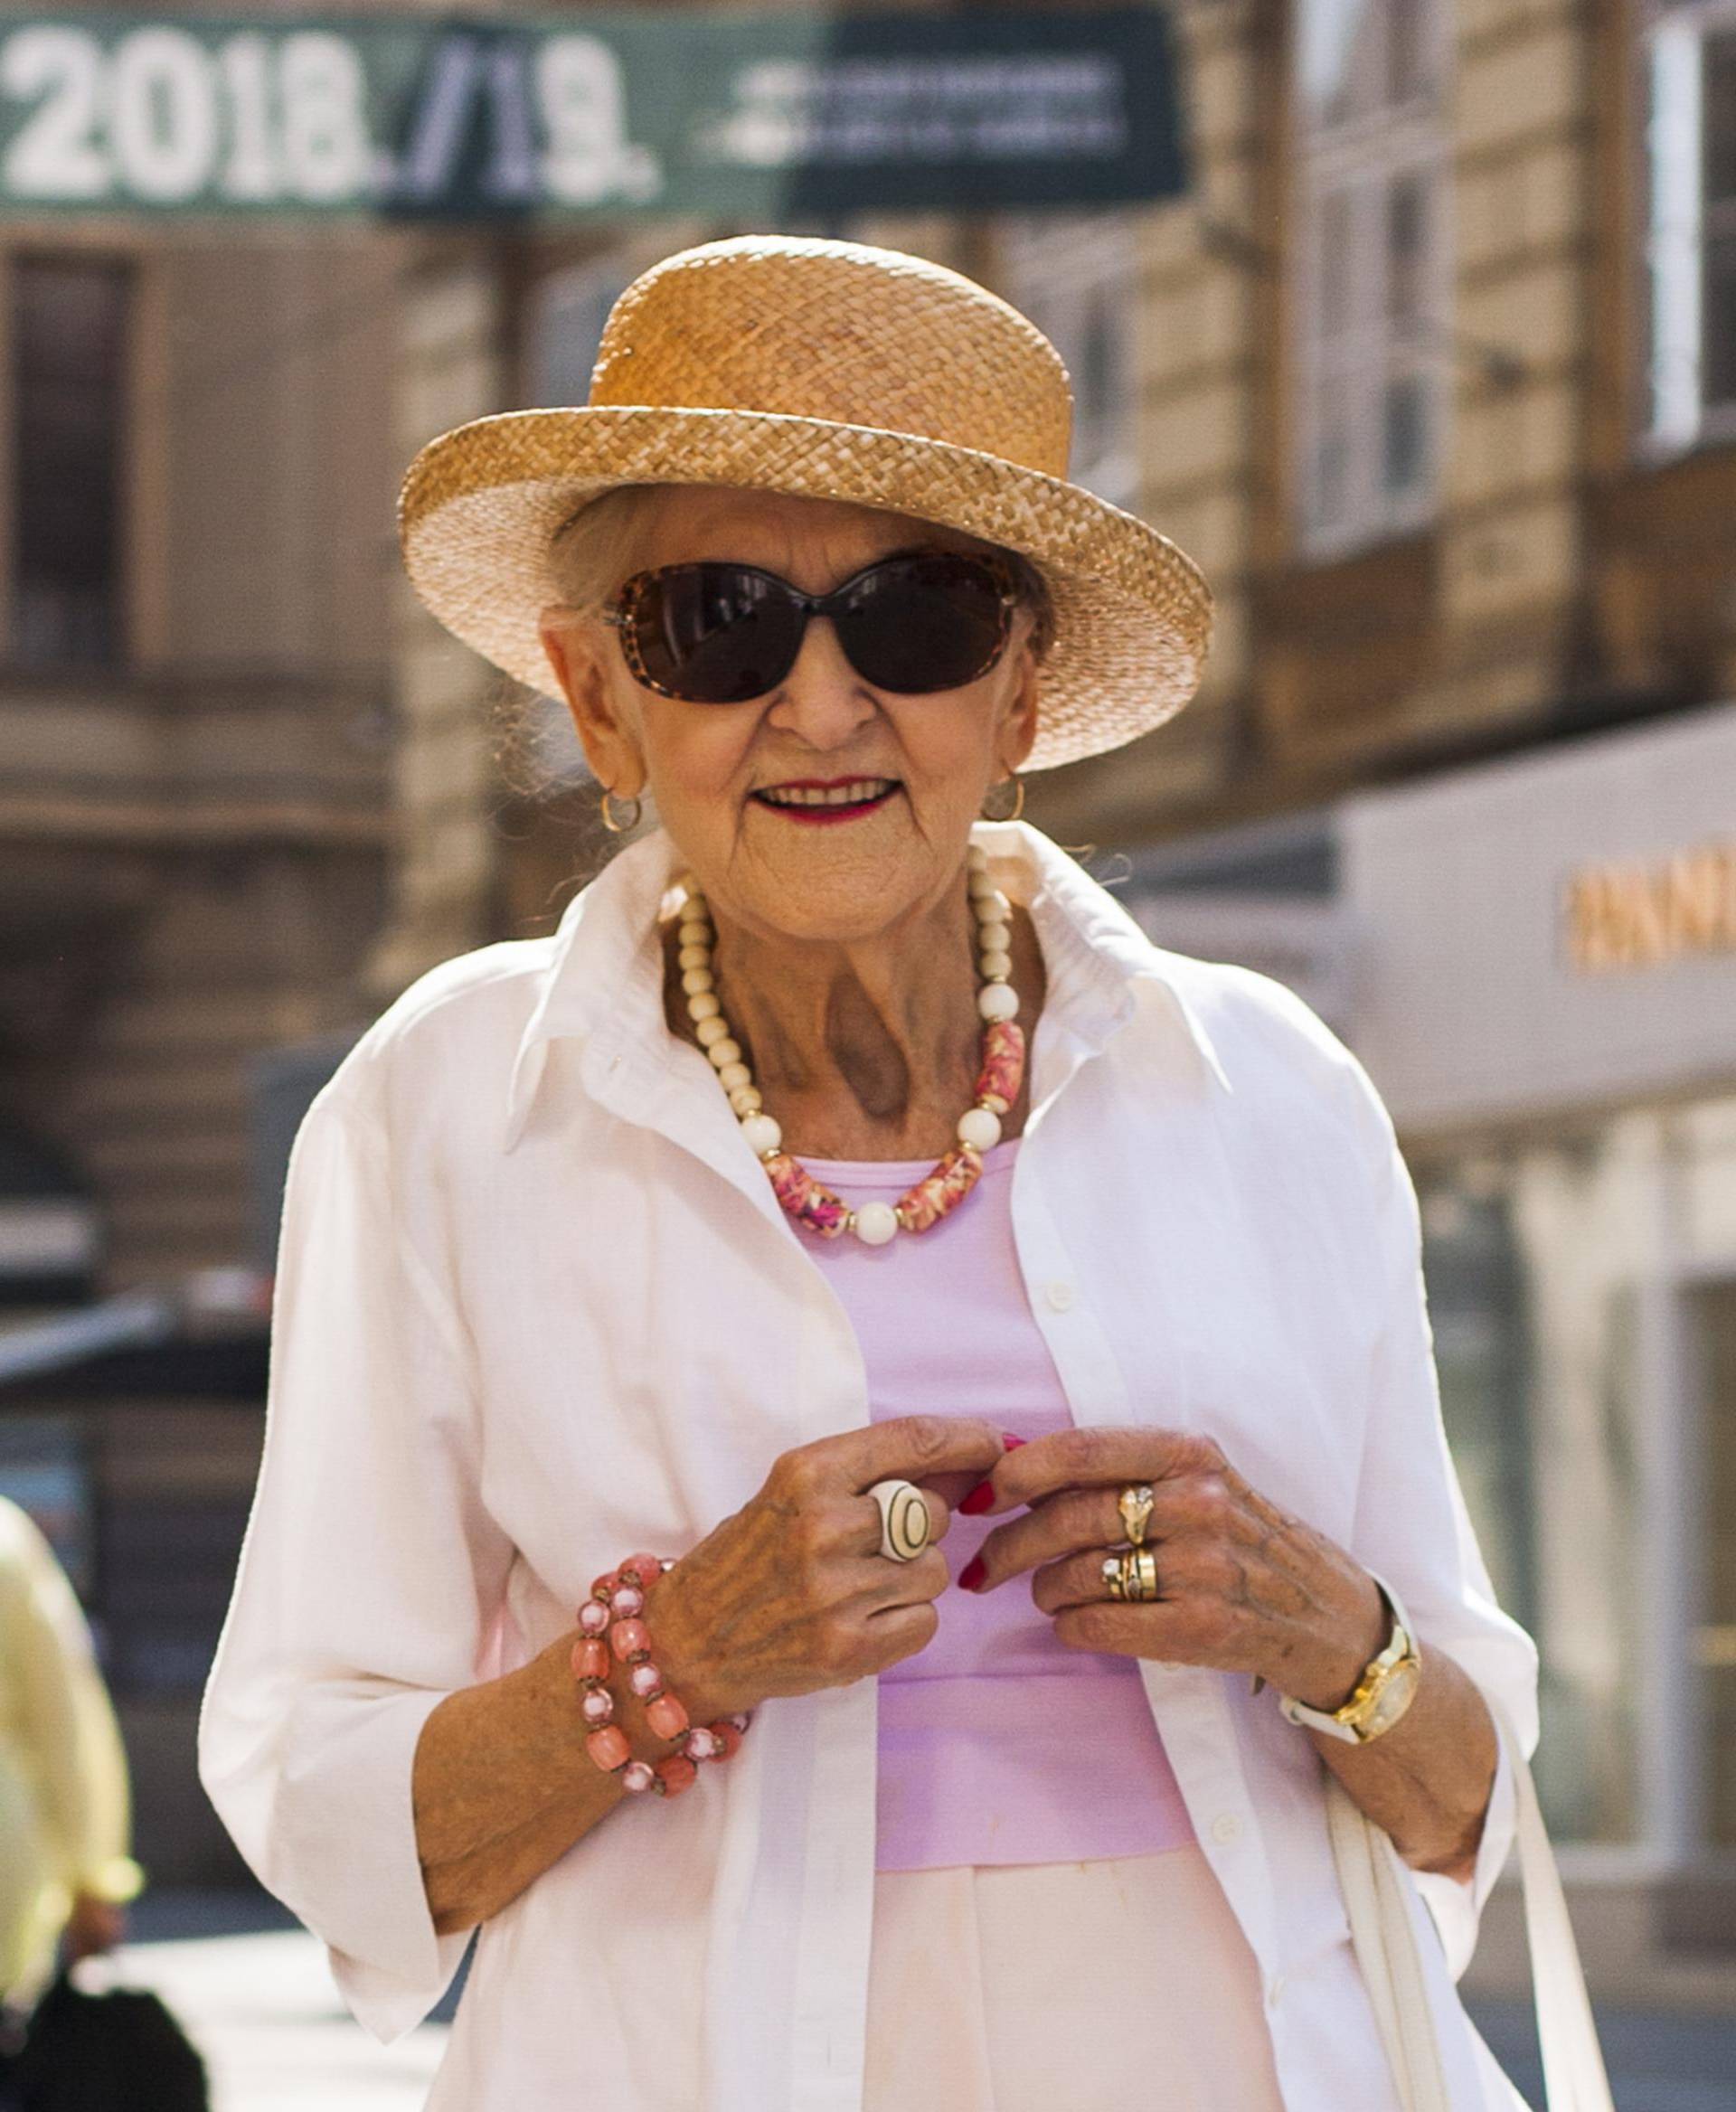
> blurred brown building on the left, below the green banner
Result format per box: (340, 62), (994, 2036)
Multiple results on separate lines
(0, 215), (401, 1878)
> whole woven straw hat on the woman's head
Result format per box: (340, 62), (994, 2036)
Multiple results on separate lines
(399, 234), (1212, 768)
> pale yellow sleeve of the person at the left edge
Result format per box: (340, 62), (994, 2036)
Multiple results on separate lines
(5, 1510), (144, 1907)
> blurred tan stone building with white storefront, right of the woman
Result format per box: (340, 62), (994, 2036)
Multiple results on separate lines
(1007, 0), (1736, 2003)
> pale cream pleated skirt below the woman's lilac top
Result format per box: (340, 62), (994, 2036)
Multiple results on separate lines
(862, 1843), (1284, 2112)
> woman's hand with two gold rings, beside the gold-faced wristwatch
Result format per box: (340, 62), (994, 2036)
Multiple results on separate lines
(958, 1426), (1390, 1709)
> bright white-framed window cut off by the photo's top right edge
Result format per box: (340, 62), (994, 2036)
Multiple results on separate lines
(1646, 0), (1736, 450)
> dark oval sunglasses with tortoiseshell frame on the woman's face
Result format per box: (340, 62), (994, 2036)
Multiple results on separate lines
(602, 552), (1018, 703)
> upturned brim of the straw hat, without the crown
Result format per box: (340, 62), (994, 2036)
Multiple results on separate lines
(399, 406), (1212, 771)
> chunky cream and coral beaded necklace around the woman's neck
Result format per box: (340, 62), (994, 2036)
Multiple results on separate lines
(678, 844), (1024, 1246)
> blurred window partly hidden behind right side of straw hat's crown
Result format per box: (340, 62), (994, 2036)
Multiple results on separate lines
(999, 213), (1138, 507)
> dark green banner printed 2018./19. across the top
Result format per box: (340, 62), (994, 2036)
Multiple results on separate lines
(0, 6), (1183, 222)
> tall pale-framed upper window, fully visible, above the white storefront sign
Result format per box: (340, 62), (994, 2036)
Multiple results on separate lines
(1295, 0), (1448, 558)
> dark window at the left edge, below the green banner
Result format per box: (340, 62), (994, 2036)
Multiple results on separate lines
(8, 256), (131, 667)
